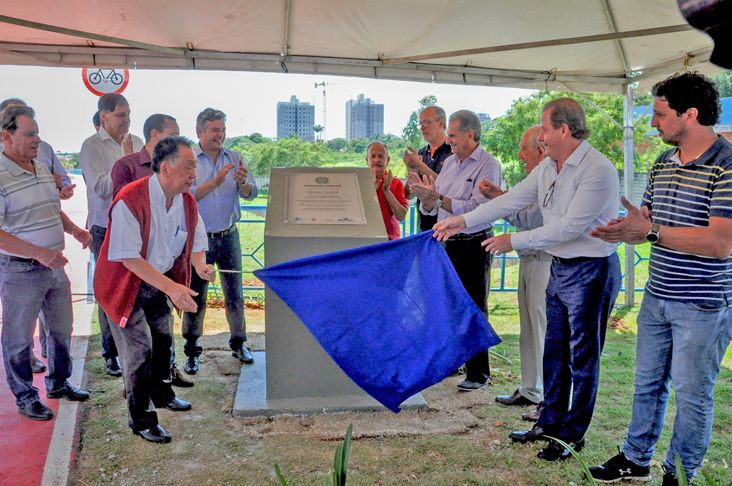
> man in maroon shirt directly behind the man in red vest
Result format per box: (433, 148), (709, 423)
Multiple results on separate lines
(112, 113), (180, 197)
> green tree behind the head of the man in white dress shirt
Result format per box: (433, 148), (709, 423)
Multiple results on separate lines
(481, 92), (663, 186)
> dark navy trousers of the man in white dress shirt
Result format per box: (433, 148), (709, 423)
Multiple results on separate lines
(538, 253), (620, 442)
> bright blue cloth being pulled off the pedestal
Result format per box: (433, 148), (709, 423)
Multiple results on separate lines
(254, 231), (501, 412)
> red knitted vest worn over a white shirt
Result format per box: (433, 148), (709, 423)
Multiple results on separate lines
(94, 177), (198, 327)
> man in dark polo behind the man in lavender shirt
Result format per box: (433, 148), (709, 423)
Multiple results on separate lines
(404, 106), (452, 231)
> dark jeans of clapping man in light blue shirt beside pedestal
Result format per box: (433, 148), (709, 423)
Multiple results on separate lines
(183, 229), (247, 356)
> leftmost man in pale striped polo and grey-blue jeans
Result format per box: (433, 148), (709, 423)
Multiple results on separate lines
(0, 105), (92, 420)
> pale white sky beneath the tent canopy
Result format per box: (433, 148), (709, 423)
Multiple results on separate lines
(0, 66), (532, 152)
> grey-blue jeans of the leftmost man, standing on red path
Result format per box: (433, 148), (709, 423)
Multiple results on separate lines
(0, 256), (73, 407)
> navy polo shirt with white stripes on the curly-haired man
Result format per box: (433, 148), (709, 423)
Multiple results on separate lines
(643, 137), (732, 307)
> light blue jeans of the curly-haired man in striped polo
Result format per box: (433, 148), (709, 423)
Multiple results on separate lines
(623, 292), (732, 478)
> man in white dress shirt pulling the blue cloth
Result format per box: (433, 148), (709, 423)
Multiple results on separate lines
(435, 98), (620, 461)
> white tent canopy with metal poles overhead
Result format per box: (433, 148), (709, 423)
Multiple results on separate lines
(0, 0), (715, 94)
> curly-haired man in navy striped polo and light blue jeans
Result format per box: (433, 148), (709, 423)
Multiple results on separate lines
(591, 72), (732, 484)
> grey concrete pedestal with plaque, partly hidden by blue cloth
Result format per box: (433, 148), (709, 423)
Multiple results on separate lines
(234, 168), (426, 416)
